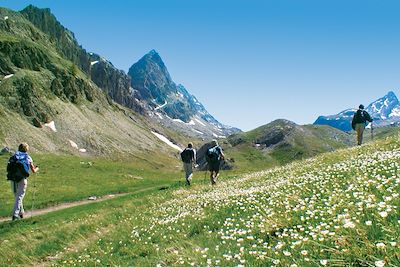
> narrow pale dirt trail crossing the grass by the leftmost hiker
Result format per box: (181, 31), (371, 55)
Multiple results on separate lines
(0, 185), (168, 223)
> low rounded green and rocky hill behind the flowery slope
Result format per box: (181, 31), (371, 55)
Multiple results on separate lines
(225, 120), (353, 169)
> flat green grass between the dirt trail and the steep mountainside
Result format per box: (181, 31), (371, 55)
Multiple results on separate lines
(0, 154), (182, 217)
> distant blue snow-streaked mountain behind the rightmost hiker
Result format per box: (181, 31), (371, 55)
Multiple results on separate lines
(314, 91), (400, 131)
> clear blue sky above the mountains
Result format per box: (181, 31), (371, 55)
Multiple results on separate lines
(0, 0), (400, 130)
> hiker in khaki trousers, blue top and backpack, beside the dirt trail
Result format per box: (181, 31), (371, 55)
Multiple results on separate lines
(7, 143), (39, 221)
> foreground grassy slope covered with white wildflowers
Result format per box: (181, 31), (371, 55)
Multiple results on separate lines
(0, 133), (400, 266)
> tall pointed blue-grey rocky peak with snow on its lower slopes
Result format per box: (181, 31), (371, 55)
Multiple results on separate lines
(128, 50), (240, 138)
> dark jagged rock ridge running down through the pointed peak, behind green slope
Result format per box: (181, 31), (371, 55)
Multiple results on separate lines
(14, 5), (240, 138)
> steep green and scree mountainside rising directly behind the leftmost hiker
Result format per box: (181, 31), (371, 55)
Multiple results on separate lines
(0, 8), (192, 161)
